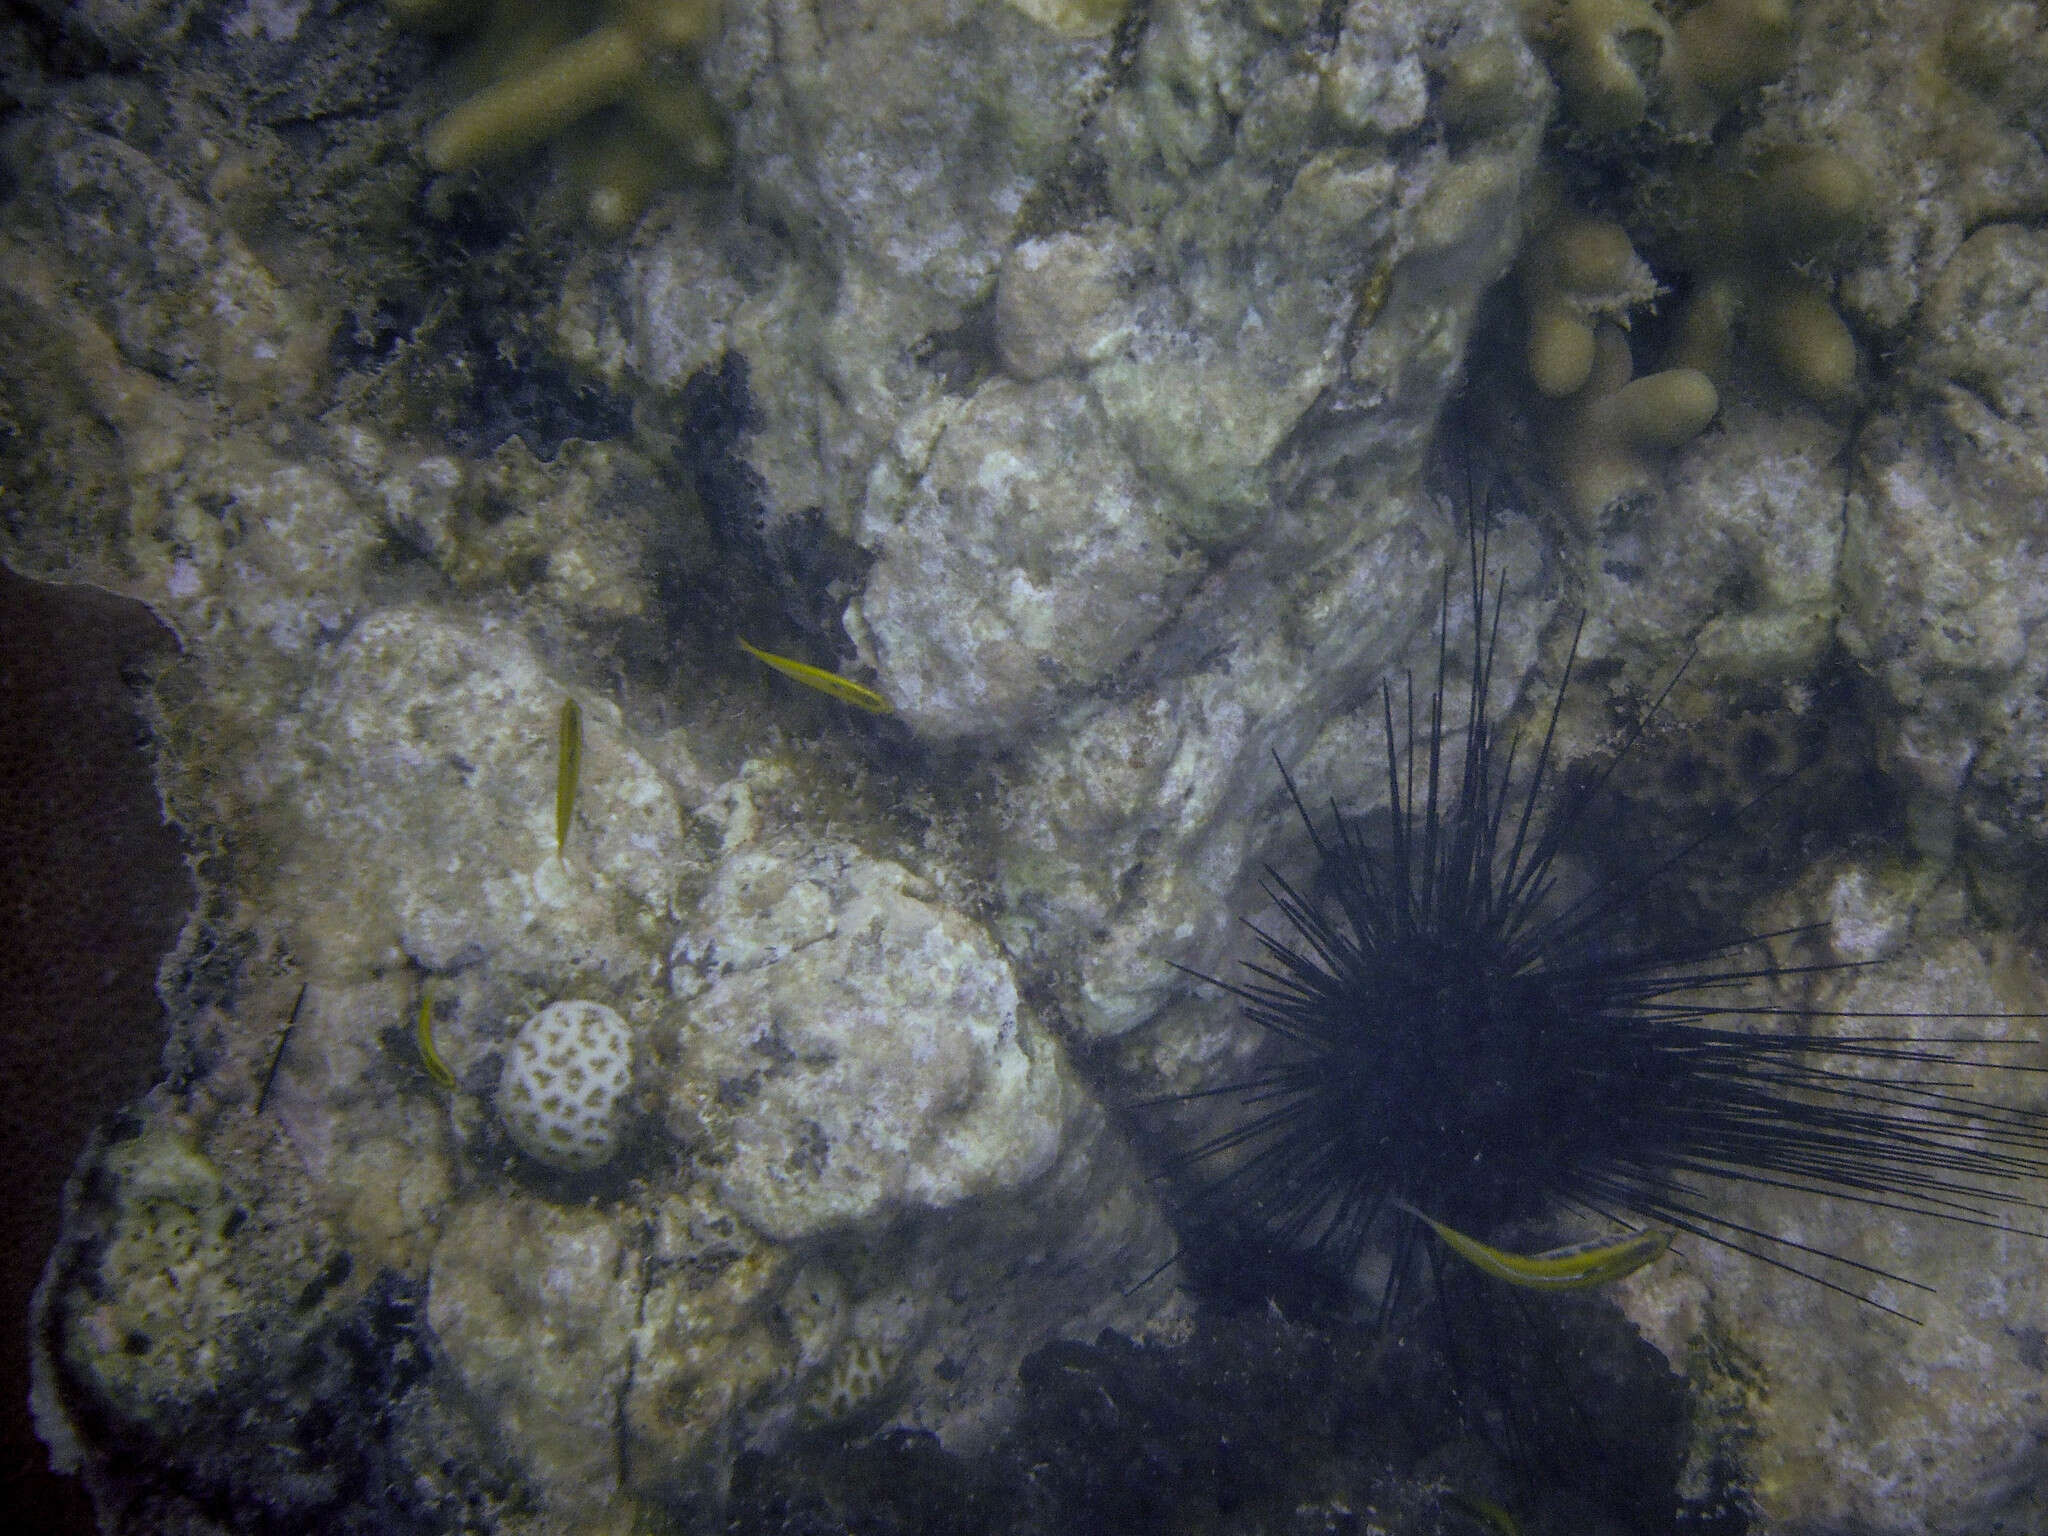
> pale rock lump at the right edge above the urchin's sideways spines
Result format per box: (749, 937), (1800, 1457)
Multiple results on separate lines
(1845, 223), (2048, 899)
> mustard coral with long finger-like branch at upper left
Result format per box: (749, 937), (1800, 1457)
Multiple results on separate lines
(387, 0), (727, 231)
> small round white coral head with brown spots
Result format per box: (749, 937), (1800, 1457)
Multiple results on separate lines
(498, 1001), (633, 1171)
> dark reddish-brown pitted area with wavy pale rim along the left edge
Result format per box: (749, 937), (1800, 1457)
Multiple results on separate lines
(0, 567), (193, 1536)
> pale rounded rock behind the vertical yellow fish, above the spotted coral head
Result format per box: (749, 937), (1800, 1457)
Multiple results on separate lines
(264, 608), (684, 979)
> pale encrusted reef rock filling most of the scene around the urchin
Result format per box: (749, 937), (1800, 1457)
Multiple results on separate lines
(12, 0), (2048, 1536)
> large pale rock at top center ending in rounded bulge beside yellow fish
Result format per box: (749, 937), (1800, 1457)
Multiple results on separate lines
(635, 4), (1544, 753)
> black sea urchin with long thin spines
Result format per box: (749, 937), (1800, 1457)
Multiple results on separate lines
(1186, 543), (2048, 1311)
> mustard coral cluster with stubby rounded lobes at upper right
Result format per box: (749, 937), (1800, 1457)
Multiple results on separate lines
(1518, 0), (1859, 456)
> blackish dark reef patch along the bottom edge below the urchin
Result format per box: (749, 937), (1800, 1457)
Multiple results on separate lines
(723, 1296), (1712, 1536)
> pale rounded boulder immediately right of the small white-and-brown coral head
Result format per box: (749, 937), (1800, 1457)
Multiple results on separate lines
(670, 840), (1077, 1243)
